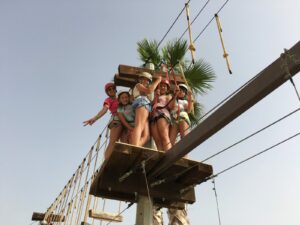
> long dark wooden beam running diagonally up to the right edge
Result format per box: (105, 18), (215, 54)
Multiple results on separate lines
(149, 42), (300, 178)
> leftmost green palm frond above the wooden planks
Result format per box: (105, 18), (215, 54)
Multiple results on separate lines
(137, 39), (161, 69)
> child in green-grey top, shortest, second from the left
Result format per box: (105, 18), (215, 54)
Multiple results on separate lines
(117, 91), (134, 143)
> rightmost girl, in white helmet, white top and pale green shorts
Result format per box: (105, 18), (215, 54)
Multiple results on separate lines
(170, 84), (193, 145)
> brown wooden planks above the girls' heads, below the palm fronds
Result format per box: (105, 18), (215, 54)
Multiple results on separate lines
(114, 65), (184, 88)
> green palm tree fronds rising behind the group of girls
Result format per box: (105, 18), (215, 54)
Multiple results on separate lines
(138, 39), (215, 127)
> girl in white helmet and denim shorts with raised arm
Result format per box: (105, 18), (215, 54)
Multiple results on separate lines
(131, 72), (161, 146)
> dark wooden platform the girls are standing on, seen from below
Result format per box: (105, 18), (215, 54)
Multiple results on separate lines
(90, 142), (213, 208)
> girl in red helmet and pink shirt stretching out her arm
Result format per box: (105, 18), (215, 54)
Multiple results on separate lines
(83, 82), (122, 160)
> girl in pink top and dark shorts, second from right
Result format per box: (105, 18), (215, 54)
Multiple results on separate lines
(150, 80), (172, 151)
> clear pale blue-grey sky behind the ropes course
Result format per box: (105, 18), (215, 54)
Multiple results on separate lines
(0, 0), (300, 225)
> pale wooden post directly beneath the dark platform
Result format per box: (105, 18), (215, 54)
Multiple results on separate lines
(135, 195), (153, 225)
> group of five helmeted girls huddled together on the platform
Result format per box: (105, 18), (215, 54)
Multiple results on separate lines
(83, 72), (193, 159)
